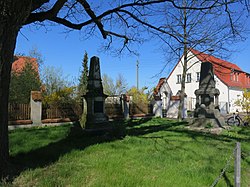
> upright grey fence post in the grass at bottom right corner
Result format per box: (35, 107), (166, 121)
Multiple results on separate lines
(234, 142), (241, 187)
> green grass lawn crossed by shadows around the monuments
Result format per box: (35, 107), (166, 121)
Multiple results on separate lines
(0, 118), (250, 187)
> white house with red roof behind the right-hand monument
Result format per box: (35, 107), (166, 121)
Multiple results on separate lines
(155, 49), (250, 113)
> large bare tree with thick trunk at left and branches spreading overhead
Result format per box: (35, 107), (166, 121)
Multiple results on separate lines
(0, 0), (247, 176)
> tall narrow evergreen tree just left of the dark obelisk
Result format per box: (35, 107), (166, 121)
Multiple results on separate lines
(78, 51), (89, 97)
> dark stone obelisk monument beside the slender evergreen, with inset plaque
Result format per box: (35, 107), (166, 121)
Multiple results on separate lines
(84, 56), (108, 129)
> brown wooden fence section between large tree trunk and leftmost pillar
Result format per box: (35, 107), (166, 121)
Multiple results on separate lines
(8, 104), (30, 121)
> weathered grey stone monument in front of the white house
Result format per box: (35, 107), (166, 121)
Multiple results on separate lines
(194, 62), (225, 127)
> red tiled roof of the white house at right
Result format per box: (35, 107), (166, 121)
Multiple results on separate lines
(190, 49), (250, 89)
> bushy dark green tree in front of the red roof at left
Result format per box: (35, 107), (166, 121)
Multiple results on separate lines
(9, 61), (41, 104)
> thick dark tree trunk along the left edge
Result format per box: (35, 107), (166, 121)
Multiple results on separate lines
(0, 0), (31, 178)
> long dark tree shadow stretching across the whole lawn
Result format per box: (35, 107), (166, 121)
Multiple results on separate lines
(4, 118), (250, 181)
